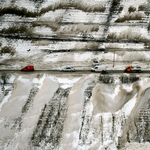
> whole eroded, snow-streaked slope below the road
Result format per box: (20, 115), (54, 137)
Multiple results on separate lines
(0, 73), (150, 150)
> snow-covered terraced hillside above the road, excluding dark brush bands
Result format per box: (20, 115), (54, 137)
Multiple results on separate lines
(0, 0), (150, 69)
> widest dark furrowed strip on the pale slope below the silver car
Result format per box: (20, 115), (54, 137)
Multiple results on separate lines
(31, 88), (70, 149)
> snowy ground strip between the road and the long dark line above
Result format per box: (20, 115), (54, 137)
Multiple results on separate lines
(0, 39), (150, 70)
